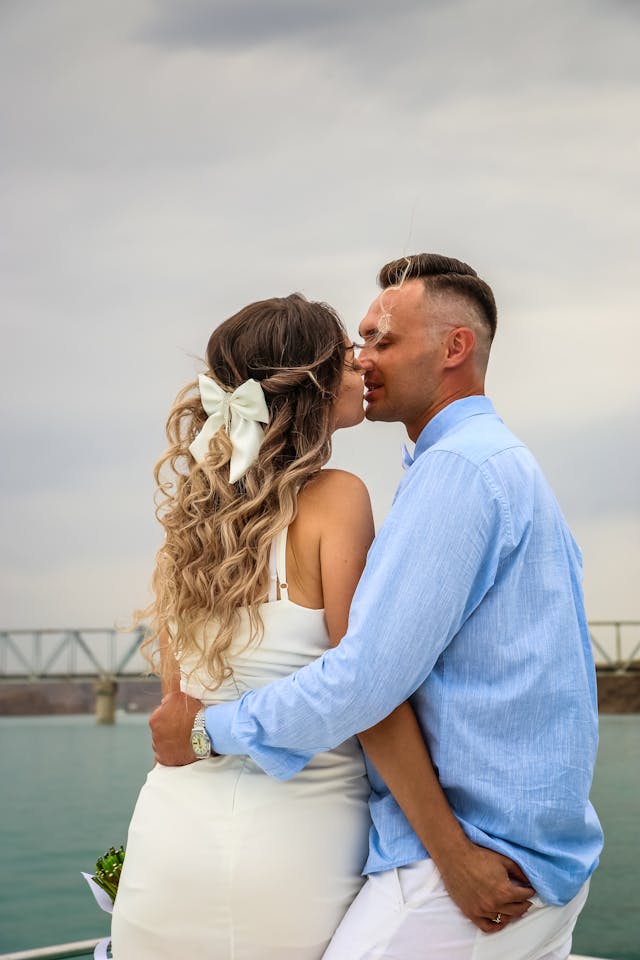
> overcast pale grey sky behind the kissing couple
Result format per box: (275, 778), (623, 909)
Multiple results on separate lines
(0, 0), (640, 644)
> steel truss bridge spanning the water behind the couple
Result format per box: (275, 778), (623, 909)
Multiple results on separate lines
(0, 620), (640, 683)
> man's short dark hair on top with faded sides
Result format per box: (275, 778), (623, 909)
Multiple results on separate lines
(378, 253), (498, 340)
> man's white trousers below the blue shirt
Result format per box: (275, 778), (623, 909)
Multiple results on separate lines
(324, 860), (589, 960)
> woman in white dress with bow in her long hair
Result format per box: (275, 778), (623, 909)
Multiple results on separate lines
(112, 294), (516, 960)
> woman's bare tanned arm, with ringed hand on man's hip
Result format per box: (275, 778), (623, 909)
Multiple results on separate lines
(320, 471), (534, 933)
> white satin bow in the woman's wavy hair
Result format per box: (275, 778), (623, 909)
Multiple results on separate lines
(189, 373), (269, 483)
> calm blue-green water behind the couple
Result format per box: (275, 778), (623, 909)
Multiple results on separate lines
(0, 716), (640, 960)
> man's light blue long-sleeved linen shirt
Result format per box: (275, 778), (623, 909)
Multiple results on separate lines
(206, 396), (602, 904)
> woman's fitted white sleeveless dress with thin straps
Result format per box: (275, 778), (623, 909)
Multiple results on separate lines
(112, 531), (369, 960)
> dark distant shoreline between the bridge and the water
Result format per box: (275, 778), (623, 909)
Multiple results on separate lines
(0, 670), (640, 717)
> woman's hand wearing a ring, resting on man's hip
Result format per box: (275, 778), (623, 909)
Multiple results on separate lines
(436, 840), (535, 933)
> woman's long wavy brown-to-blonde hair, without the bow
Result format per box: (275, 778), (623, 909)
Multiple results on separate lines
(139, 293), (346, 689)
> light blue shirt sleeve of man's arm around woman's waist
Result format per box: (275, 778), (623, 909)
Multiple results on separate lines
(205, 450), (506, 779)
